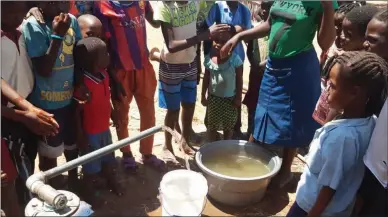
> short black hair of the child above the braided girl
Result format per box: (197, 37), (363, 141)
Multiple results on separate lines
(345, 5), (379, 35)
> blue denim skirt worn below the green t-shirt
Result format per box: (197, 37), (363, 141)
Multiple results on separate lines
(253, 49), (321, 147)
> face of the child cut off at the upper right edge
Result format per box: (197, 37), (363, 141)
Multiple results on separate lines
(364, 9), (388, 61)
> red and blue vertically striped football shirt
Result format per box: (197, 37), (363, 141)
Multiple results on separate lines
(93, 1), (152, 71)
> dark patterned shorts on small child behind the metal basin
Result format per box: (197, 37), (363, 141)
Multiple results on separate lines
(206, 95), (238, 131)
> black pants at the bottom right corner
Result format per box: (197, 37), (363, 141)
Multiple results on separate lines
(358, 167), (388, 217)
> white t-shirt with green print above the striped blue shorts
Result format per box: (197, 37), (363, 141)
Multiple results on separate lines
(154, 0), (206, 64)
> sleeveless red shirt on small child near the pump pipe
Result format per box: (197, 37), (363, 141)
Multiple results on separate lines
(83, 71), (111, 134)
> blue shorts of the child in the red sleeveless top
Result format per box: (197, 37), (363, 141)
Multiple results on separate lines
(82, 129), (115, 174)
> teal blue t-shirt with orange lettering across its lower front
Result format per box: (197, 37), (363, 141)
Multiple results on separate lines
(22, 14), (81, 110)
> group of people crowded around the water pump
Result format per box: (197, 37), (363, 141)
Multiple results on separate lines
(1, 0), (388, 216)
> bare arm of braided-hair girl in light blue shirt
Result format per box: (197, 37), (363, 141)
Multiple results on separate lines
(307, 186), (335, 217)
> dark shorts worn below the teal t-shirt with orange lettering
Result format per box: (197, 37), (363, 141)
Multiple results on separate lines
(38, 105), (77, 158)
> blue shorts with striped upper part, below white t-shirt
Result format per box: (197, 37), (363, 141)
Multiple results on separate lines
(159, 59), (198, 110)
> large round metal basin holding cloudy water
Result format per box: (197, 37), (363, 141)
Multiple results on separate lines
(195, 140), (281, 206)
